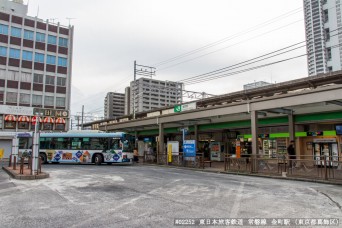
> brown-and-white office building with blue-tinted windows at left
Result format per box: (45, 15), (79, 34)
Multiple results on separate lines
(0, 0), (74, 131)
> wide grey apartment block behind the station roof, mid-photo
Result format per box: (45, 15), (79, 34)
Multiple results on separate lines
(130, 78), (183, 114)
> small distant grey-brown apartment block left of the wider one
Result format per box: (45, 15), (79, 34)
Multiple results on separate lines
(104, 92), (125, 119)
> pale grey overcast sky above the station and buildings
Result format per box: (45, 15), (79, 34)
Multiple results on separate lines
(25, 0), (307, 116)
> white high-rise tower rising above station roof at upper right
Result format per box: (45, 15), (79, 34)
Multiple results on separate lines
(304, 0), (342, 76)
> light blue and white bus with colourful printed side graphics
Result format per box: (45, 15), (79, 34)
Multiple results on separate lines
(14, 132), (135, 165)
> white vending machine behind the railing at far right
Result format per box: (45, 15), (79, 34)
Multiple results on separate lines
(312, 139), (338, 167)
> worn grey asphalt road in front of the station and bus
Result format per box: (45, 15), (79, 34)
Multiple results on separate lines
(0, 165), (342, 228)
